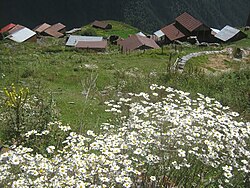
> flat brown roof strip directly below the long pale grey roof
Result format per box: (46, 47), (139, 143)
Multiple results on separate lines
(75, 40), (108, 49)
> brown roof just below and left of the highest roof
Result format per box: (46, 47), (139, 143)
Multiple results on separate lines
(161, 23), (185, 41)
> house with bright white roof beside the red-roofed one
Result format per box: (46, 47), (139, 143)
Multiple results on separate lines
(7, 27), (37, 43)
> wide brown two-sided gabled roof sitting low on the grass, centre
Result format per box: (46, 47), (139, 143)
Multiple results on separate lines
(119, 35), (159, 52)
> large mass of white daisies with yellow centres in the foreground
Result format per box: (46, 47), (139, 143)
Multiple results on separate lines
(0, 85), (250, 187)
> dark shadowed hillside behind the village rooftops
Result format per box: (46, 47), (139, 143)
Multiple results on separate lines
(0, 0), (250, 31)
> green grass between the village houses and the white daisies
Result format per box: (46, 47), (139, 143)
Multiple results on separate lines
(0, 27), (250, 130)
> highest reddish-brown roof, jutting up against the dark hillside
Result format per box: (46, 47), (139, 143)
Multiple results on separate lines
(175, 12), (202, 32)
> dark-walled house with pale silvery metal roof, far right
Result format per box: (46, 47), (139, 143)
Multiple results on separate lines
(215, 25), (247, 42)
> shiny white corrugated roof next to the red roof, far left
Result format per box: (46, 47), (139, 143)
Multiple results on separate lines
(7, 27), (36, 42)
